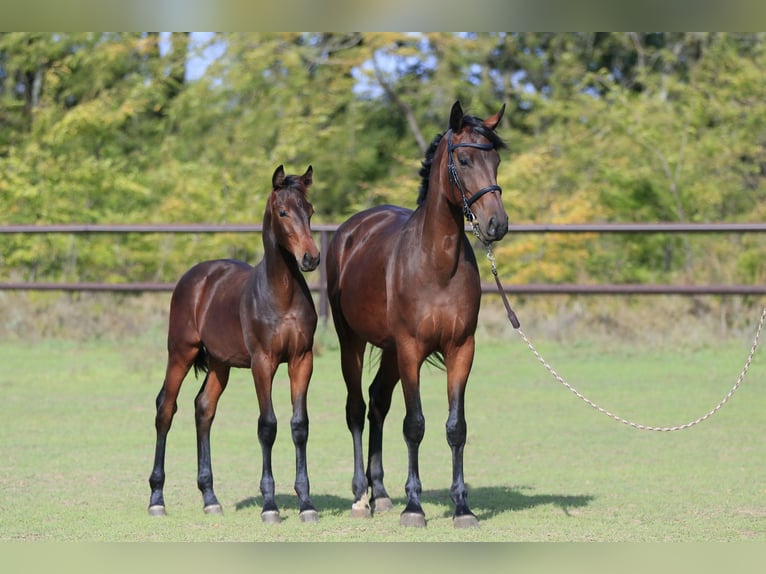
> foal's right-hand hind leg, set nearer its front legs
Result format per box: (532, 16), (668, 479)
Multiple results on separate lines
(194, 360), (229, 514)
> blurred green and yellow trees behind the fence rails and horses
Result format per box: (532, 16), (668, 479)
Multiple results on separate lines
(0, 33), (766, 290)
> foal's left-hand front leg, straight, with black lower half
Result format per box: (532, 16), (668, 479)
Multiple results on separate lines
(251, 355), (280, 524)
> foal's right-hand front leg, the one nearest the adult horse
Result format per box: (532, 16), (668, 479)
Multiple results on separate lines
(287, 350), (319, 522)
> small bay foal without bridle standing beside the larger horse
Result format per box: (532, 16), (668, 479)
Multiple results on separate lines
(149, 165), (319, 522)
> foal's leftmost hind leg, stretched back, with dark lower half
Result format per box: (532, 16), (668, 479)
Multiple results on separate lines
(148, 347), (198, 516)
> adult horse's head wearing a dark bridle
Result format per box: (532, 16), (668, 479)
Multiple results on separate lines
(443, 101), (508, 243)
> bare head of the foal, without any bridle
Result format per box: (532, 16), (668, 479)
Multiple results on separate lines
(264, 165), (319, 271)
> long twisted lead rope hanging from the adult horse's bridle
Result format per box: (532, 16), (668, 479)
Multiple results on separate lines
(471, 225), (766, 432)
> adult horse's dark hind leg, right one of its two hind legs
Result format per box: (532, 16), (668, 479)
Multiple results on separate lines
(367, 350), (399, 512)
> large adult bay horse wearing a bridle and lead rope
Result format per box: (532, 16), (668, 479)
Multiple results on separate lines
(326, 102), (508, 527)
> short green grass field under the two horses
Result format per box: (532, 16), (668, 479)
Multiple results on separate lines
(0, 306), (766, 542)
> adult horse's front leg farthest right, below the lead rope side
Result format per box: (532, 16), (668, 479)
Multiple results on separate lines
(445, 338), (479, 528)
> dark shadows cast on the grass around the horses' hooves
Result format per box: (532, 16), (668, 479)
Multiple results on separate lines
(235, 486), (594, 520)
